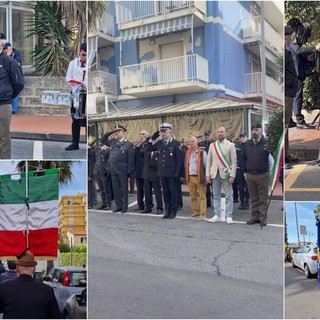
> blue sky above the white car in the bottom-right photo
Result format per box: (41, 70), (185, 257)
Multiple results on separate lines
(285, 201), (320, 243)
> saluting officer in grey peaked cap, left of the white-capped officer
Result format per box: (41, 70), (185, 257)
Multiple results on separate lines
(100, 125), (134, 213)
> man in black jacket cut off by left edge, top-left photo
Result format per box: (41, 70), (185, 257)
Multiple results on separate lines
(0, 33), (24, 159)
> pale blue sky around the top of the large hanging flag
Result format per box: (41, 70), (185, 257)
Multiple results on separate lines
(0, 160), (87, 197)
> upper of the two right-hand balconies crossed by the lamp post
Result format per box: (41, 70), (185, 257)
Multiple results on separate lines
(240, 16), (283, 54)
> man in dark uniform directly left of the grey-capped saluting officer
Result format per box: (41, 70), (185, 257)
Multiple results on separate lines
(93, 144), (112, 210)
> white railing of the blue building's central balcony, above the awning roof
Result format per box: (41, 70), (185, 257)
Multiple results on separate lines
(119, 54), (208, 89)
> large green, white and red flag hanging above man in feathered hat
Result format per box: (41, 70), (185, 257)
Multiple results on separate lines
(0, 169), (59, 257)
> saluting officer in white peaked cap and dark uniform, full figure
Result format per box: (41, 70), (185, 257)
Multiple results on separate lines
(146, 123), (182, 219)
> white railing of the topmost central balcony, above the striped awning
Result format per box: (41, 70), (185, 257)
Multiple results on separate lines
(116, 0), (205, 23)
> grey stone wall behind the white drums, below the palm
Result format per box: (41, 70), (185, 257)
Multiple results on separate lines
(18, 76), (71, 115)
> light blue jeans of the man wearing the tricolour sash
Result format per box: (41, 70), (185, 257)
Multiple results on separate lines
(212, 172), (233, 217)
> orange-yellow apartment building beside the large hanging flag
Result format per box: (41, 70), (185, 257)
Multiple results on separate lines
(59, 193), (87, 246)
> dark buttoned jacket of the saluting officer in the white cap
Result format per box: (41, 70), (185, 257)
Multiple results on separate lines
(146, 138), (184, 178)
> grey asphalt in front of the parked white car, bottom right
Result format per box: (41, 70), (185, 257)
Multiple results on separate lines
(285, 263), (320, 319)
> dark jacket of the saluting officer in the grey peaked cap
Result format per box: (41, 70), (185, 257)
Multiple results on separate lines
(101, 134), (134, 176)
